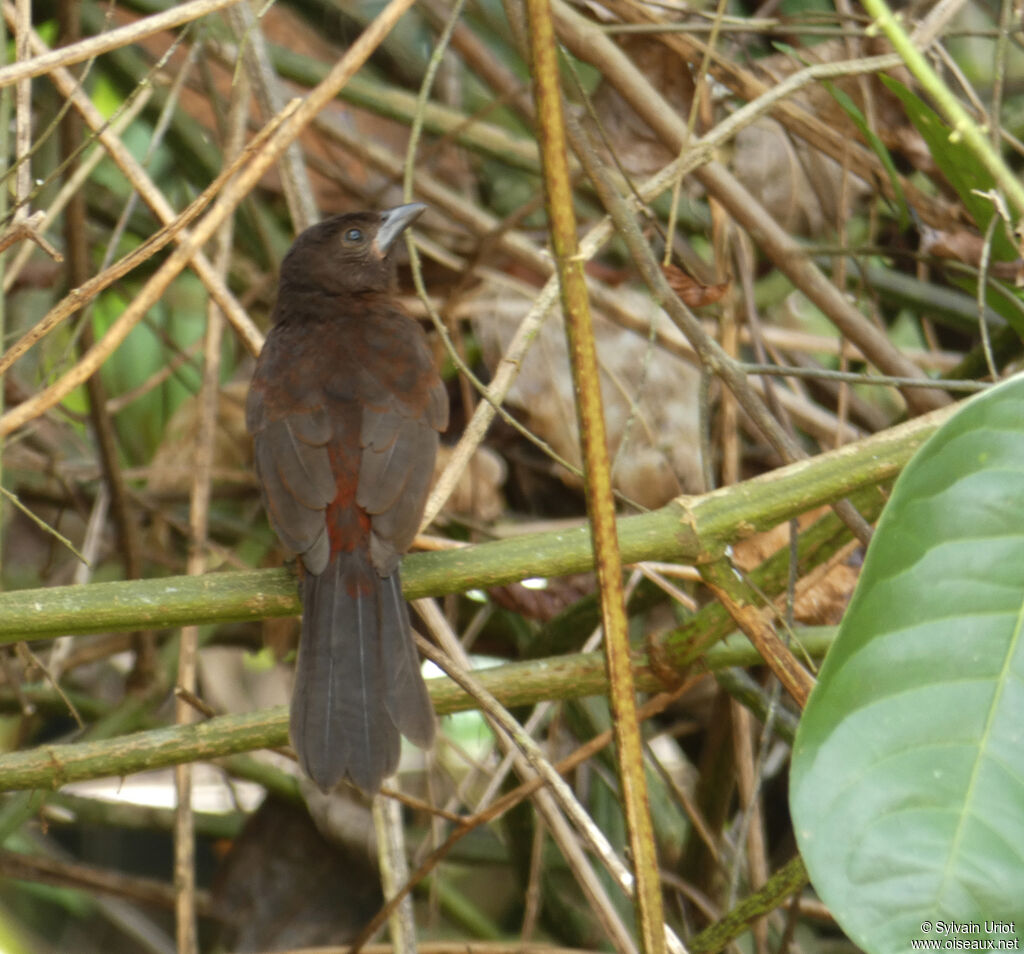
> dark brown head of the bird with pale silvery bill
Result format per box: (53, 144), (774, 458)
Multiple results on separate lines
(281, 202), (427, 295)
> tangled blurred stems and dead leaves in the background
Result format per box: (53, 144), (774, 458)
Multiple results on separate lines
(0, 0), (1024, 952)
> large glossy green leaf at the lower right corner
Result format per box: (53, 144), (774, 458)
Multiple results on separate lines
(791, 377), (1024, 954)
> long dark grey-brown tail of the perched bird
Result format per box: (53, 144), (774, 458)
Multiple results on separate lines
(291, 550), (434, 792)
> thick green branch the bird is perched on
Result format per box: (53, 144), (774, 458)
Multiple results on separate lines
(0, 407), (953, 644)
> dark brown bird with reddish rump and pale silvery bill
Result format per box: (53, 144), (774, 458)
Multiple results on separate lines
(246, 203), (449, 792)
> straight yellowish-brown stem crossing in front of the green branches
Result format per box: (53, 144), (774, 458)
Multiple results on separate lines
(526, 0), (666, 954)
